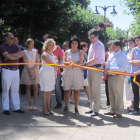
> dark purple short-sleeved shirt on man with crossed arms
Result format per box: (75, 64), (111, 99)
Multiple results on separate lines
(0, 43), (21, 69)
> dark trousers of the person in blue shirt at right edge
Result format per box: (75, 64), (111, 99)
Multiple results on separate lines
(131, 74), (140, 112)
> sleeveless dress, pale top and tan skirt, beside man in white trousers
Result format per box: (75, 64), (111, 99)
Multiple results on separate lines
(20, 49), (39, 85)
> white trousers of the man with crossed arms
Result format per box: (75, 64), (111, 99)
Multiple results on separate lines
(2, 68), (20, 111)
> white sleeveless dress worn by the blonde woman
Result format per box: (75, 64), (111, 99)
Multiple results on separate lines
(39, 52), (56, 92)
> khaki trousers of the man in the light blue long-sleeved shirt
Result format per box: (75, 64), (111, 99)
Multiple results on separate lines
(108, 75), (124, 115)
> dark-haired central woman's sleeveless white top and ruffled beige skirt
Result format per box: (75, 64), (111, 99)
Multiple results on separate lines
(62, 50), (84, 90)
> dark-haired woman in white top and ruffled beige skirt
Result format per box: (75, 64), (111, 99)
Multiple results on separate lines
(62, 36), (84, 116)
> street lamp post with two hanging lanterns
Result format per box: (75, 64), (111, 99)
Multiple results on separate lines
(93, 5), (117, 47)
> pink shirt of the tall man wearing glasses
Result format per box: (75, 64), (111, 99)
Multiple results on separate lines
(88, 40), (105, 66)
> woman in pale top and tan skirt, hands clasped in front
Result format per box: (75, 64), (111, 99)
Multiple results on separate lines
(20, 39), (39, 111)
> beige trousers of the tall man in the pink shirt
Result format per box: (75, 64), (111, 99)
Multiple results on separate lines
(87, 70), (102, 112)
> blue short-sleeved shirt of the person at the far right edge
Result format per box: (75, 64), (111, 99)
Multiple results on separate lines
(131, 46), (140, 73)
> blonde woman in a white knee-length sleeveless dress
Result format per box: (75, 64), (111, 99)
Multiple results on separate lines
(40, 39), (56, 116)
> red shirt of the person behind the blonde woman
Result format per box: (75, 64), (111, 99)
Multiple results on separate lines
(53, 45), (63, 74)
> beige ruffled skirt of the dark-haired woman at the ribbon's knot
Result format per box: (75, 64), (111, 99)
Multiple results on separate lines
(61, 67), (84, 90)
